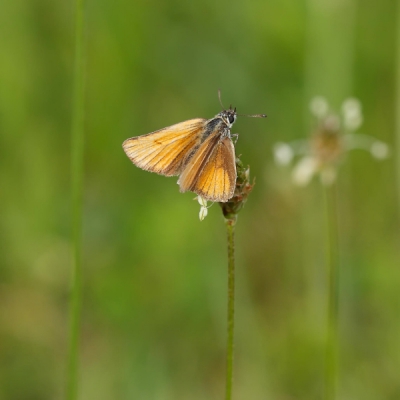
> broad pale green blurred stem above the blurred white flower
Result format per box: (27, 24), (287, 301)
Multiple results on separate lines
(305, 0), (357, 111)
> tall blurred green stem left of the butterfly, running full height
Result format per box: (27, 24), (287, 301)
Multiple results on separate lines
(66, 0), (85, 400)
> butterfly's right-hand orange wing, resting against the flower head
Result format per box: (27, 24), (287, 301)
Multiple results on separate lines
(178, 132), (236, 202)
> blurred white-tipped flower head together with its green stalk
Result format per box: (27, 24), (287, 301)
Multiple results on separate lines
(274, 96), (390, 400)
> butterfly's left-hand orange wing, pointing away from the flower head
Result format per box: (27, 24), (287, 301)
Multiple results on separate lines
(122, 118), (207, 176)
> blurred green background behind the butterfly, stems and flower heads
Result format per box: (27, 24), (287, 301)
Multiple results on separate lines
(0, 0), (400, 400)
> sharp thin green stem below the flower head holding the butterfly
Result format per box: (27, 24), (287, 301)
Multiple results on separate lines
(225, 219), (236, 400)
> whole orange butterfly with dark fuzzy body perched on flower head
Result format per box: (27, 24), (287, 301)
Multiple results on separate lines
(122, 92), (266, 203)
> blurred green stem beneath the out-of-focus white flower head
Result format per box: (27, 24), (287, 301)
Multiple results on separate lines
(325, 185), (339, 400)
